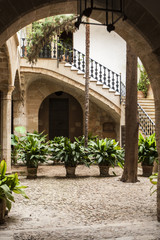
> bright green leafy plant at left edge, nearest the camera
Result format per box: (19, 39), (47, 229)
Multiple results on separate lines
(0, 160), (28, 224)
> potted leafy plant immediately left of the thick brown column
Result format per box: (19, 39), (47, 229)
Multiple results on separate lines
(90, 138), (124, 177)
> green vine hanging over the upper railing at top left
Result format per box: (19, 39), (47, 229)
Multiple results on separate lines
(27, 15), (77, 64)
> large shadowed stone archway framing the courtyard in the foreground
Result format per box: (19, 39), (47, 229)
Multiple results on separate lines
(0, 0), (160, 220)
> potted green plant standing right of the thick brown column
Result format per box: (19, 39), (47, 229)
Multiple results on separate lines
(138, 133), (158, 177)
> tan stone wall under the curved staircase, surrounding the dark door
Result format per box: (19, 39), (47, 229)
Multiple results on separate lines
(19, 74), (120, 140)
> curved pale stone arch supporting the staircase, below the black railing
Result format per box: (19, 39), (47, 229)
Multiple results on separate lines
(21, 62), (121, 118)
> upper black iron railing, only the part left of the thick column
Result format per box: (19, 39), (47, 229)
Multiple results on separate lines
(21, 38), (121, 94)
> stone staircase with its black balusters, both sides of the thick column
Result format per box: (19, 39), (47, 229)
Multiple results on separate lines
(21, 39), (155, 136)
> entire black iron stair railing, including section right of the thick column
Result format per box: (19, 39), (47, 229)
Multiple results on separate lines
(21, 38), (155, 135)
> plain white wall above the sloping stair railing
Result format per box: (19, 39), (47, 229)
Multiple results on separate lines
(73, 19), (126, 82)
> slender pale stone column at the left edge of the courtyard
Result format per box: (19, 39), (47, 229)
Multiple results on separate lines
(1, 86), (14, 173)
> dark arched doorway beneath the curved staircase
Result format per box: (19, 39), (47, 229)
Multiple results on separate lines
(38, 91), (83, 140)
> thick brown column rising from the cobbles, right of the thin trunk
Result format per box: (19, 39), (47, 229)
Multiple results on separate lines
(121, 45), (139, 182)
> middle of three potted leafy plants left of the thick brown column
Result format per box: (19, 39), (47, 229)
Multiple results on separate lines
(51, 137), (89, 177)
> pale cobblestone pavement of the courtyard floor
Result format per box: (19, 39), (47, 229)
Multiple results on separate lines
(0, 166), (160, 240)
